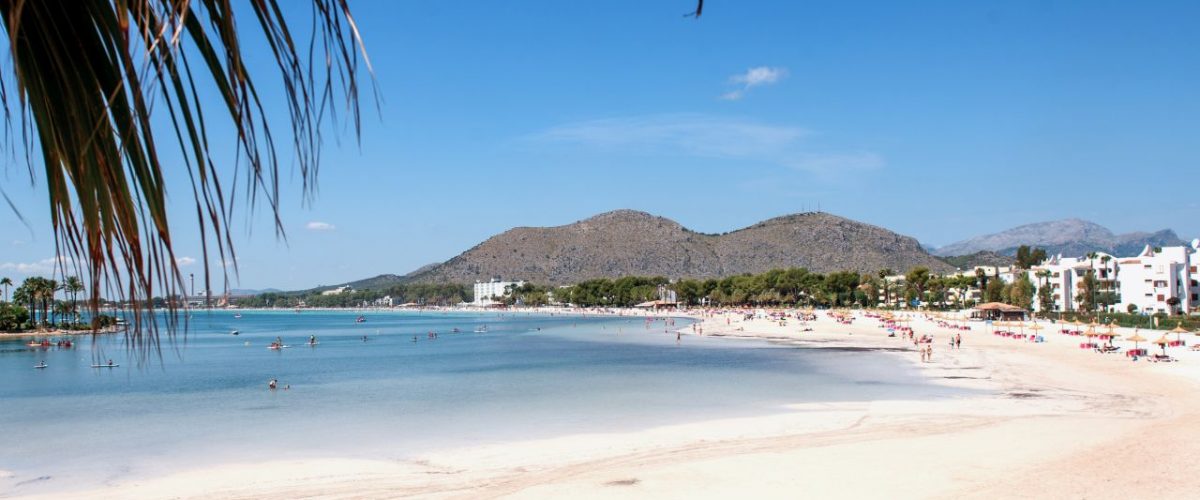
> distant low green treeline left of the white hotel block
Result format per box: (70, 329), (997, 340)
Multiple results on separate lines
(233, 280), (472, 308)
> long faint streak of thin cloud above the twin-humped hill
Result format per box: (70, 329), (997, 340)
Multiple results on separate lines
(526, 114), (884, 174)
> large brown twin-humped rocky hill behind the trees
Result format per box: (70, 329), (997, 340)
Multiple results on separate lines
(410, 210), (952, 284)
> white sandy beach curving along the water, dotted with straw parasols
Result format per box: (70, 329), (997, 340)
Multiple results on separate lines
(23, 314), (1200, 499)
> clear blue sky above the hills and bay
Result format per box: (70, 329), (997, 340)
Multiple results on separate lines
(0, 0), (1200, 289)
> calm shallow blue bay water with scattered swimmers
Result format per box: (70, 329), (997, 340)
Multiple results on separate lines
(0, 312), (961, 495)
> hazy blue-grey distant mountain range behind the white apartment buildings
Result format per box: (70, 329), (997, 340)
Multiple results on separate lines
(934, 218), (1184, 257)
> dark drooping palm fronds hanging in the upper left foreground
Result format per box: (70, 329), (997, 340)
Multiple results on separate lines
(0, 0), (373, 345)
